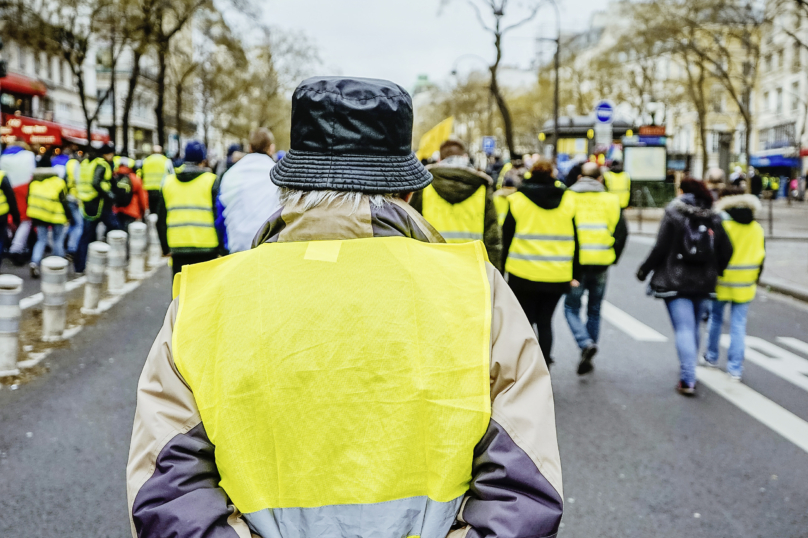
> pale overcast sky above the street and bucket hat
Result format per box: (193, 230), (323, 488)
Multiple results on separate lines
(265, 0), (605, 89)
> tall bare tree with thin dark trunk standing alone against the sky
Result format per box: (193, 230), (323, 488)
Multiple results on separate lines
(441, 0), (542, 155)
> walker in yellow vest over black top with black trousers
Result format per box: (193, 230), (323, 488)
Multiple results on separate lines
(502, 157), (575, 367)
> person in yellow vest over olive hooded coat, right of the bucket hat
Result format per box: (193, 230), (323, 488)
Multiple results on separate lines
(410, 140), (502, 271)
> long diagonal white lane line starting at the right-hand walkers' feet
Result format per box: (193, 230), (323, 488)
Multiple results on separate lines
(696, 366), (808, 452)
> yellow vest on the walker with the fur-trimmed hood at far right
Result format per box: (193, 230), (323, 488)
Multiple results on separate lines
(715, 220), (766, 303)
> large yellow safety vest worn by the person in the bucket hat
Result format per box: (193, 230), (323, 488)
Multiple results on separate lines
(172, 237), (491, 538)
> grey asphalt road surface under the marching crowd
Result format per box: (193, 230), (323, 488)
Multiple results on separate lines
(0, 241), (808, 538)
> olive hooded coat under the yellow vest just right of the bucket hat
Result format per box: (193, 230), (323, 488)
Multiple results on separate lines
(410, 164), (504, 272)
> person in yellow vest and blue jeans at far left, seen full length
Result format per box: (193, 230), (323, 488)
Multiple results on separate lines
(27, 169), (73, 278)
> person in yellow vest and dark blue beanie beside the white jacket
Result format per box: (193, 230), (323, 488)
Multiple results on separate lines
(157, 140), (221, 275)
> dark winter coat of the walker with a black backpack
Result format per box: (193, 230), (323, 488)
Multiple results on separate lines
(637, 194), (732, 299)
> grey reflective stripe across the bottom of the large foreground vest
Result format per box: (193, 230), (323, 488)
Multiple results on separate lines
(243, 496), (463, 538)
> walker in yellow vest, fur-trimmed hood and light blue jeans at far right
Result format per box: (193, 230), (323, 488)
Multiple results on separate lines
(702, 188), (766, 381)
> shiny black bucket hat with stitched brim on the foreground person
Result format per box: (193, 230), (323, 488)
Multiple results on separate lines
(270, 77), (432, 194)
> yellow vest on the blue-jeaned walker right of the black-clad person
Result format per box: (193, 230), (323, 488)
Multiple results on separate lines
(570, 191), (620, 265)
